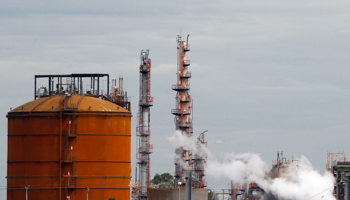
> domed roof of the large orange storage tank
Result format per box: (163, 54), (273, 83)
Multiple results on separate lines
(9, 95), (130, 113)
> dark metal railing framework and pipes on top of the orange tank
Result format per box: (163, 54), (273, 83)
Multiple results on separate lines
(34, 74), (130, 111)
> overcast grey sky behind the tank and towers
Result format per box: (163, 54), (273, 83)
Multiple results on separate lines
(0, 0), (350, 199)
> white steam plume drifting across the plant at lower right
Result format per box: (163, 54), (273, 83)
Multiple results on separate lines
(169, 131), (335, 200)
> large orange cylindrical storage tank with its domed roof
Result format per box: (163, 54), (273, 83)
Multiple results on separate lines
(7, 95), (131, 200)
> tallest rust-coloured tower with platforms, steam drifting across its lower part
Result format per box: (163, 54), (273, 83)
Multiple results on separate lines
(171, 35), (193, 187)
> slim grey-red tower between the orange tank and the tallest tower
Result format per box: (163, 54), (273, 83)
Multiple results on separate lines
(136, 50), (153, 199)
